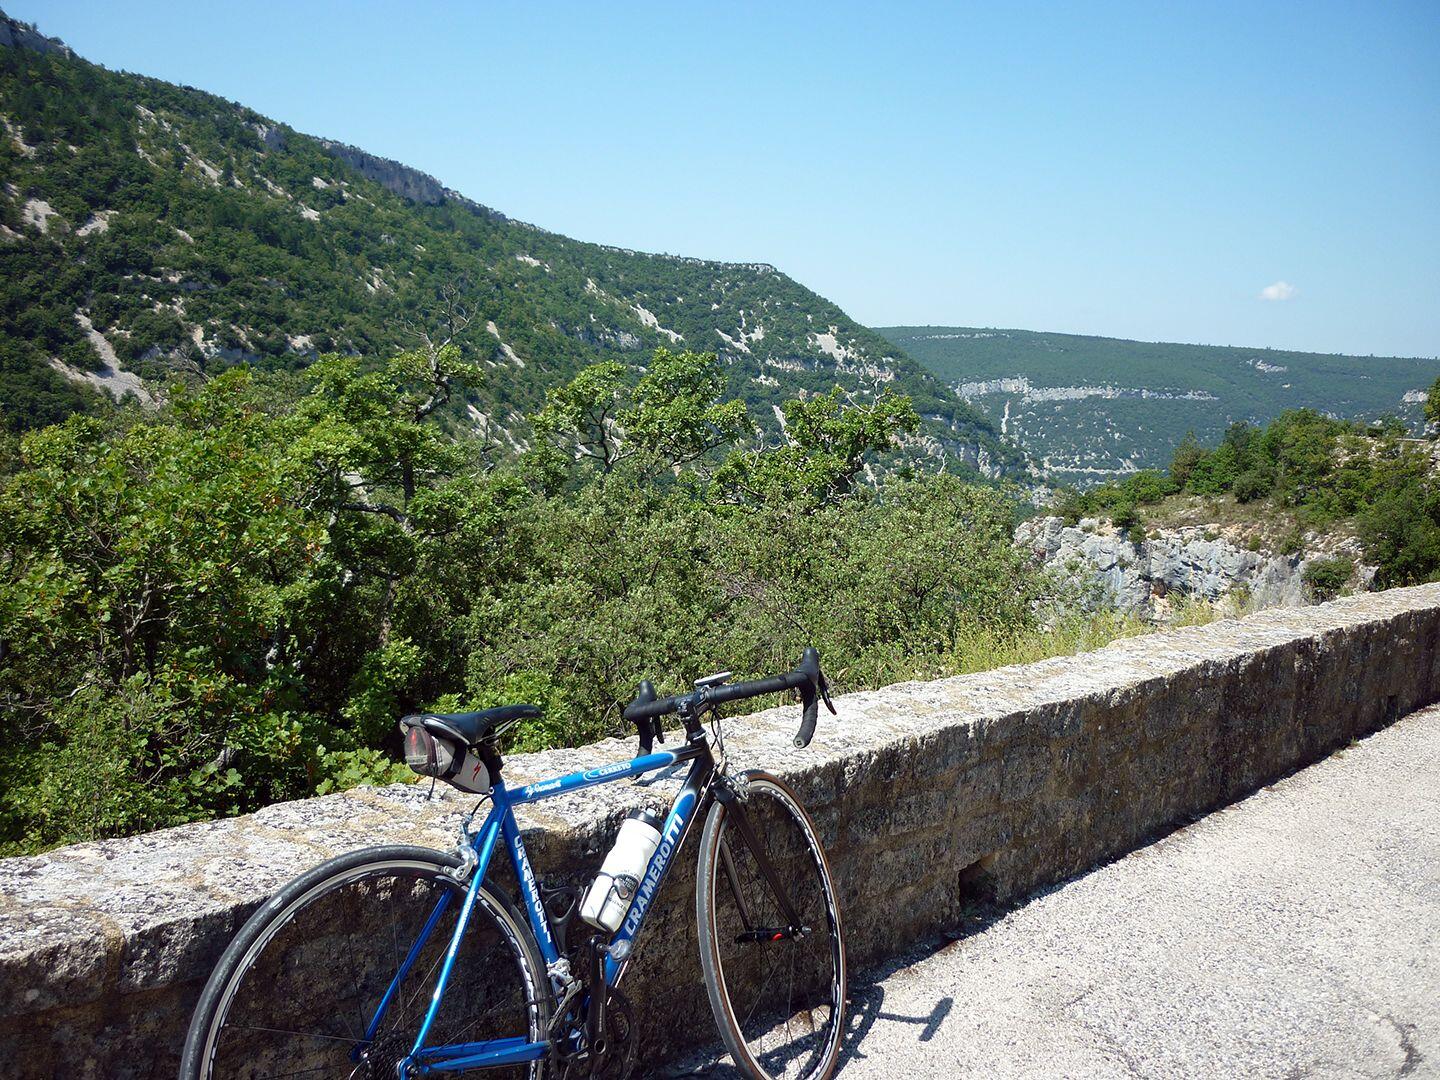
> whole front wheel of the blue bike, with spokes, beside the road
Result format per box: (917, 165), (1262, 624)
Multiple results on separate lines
(696, 772), (845, 1080)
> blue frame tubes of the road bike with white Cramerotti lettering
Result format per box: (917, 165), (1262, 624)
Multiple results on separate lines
(394, 734), (716, 1076)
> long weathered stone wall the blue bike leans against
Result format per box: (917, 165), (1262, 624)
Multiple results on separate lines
(8, 585), (1440, 1077)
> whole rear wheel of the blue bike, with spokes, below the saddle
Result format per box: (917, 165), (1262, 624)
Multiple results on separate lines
(180, 847), (550, 1080)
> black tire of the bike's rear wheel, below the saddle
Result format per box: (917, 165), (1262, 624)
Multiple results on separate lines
(180, 844), (550, 1080)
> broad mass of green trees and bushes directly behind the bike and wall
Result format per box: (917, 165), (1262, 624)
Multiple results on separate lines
(0, 343), (1050, 852)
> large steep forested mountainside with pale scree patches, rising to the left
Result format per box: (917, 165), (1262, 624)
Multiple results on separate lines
(0, 17), (1022, 475)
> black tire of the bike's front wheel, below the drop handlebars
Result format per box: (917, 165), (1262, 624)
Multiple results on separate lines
(696, 770), (847, 1080)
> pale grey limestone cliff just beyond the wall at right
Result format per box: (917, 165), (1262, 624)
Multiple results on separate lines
(1015, 517), (1375, 621)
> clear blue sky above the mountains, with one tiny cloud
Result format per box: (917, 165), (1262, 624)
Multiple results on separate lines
(14, 0), (1440, 356)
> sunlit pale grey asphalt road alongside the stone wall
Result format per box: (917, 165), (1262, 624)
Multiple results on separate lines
(662, 707), (1440, 1080)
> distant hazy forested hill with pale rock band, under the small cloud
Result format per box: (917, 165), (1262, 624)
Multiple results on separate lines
(877, 327), (1440, 482)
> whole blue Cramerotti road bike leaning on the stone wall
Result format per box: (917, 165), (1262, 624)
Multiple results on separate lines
(180, 649), (845, 1080)
